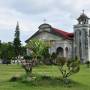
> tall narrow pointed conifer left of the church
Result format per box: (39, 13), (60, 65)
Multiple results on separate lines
(13, 22), (21, 58)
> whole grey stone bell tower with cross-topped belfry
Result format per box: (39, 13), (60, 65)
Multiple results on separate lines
(74, 10), (90, 63)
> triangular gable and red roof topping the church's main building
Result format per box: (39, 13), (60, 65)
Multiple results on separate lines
(26, 23), (74, 42)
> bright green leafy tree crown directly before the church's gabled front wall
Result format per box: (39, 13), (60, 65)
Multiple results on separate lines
(27, 39), (48, 63)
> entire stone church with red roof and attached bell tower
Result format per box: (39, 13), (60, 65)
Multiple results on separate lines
(26, 13), (90, 62)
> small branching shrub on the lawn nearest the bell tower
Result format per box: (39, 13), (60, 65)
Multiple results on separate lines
(57, 57), (80, 84)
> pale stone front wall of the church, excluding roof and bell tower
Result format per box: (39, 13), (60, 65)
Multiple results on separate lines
(27, 24), (72, 58)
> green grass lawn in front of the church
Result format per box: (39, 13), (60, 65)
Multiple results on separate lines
(0, 64), (90, 90)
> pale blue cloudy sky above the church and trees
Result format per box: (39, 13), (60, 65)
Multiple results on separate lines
(0, 0), (90, 44)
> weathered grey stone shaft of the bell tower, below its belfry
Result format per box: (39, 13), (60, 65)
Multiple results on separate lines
(74, 24), (90, 62)
